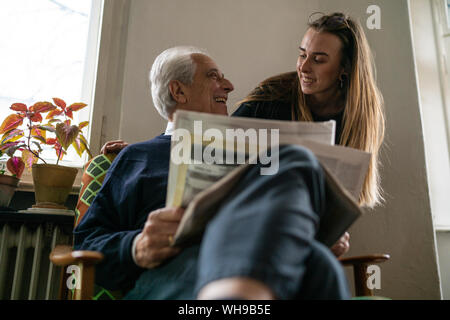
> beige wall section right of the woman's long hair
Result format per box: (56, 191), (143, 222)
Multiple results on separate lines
(321, 0), (440, 299)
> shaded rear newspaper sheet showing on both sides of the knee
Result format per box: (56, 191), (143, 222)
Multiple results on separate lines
(174, 138), (370, 247)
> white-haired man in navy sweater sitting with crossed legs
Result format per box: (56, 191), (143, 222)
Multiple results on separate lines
(74, 47), (349, 299)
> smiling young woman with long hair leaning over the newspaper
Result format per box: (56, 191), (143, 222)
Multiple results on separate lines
(233, 13), (384, 207)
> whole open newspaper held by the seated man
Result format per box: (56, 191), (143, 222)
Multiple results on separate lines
(166, 111), (370, 246)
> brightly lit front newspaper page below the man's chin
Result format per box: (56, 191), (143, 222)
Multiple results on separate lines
(166, 110), (336, 208)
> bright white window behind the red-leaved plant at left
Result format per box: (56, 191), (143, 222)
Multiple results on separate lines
(0, 0), (103, 171)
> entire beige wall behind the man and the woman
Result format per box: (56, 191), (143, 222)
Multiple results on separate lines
(102, 0), (440, 299)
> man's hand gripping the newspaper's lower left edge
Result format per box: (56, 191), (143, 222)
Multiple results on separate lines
(135, 208), (184, 268)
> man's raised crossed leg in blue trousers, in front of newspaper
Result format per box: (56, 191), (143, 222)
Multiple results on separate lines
(196, 146), (348, 299)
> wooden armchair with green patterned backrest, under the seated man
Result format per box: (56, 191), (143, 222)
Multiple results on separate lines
(50, 154), (389, 300)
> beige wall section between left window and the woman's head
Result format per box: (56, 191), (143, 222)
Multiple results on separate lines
(120, 0), (315, 141)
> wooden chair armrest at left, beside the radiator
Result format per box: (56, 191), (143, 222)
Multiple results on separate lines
(50, 245), (104, 267)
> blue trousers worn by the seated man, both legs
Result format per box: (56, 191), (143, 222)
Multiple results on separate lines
(125, 146), (350, 299)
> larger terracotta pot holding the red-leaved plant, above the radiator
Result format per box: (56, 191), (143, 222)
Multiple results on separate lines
(32, 164), (78, 209)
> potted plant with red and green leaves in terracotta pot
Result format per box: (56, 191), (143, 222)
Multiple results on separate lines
(0, 98), (92, 209)
